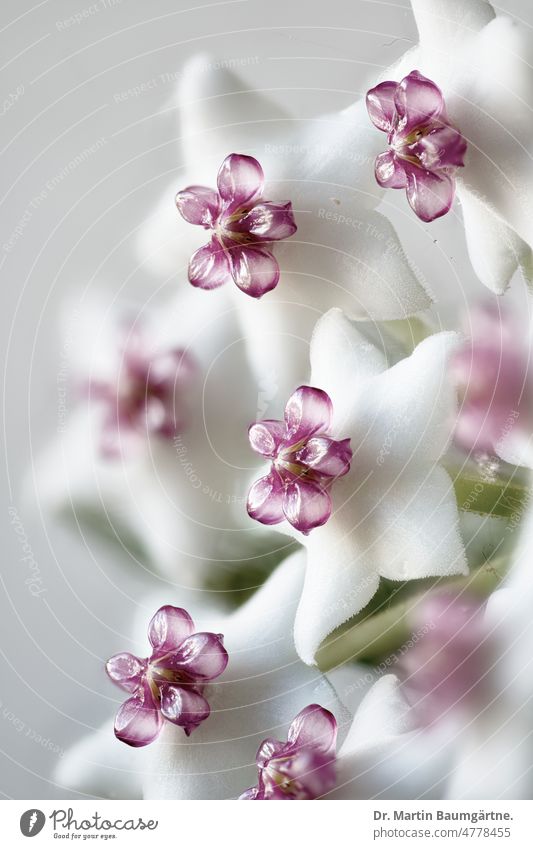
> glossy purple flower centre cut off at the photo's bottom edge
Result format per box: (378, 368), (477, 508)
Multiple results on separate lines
(239, 705), (337, 800)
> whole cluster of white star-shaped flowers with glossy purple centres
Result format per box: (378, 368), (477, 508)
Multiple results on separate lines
(39, 0), (533, 801)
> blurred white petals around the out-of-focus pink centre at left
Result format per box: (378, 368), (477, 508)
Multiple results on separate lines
(27, 286), (278, 588)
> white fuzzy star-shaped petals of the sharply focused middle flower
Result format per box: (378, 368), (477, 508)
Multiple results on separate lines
(258, 310), (467, 663)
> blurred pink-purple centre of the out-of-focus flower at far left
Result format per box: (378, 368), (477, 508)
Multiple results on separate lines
(86, 327), (197, 457)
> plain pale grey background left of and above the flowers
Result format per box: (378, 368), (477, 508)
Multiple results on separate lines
(0, 0), (533, 799)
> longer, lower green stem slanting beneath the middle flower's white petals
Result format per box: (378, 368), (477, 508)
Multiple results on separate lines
(317, 555), (510, 672)
